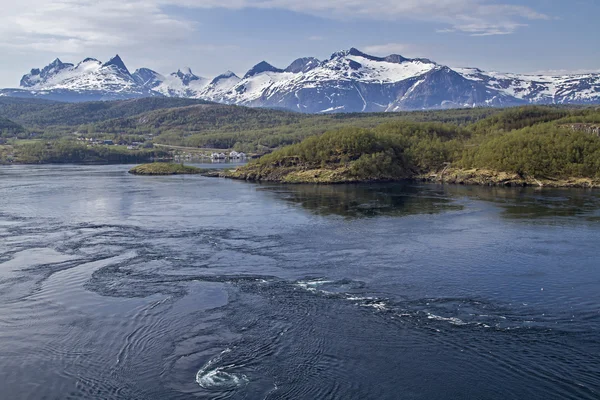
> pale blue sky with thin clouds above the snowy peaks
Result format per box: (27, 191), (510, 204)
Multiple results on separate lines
(0, 0), (600, 87)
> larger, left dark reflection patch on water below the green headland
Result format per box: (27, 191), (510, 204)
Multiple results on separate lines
(260, 183), (462, 218)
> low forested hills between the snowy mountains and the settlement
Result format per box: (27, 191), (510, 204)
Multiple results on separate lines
(0, 97), (499, 153)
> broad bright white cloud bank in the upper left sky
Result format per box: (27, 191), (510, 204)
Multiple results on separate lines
(0, 0), (194, 53)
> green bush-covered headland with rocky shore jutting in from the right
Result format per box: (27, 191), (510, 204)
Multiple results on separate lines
(224, 107), (600, 188)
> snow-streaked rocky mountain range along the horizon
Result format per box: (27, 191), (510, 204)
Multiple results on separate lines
(0, 48), (600, 113)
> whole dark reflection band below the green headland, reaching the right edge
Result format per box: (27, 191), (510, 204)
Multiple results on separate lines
(258, 183), (600, 221)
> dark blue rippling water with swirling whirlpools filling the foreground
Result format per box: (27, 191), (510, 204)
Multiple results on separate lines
(0, 165), (600, 400)
